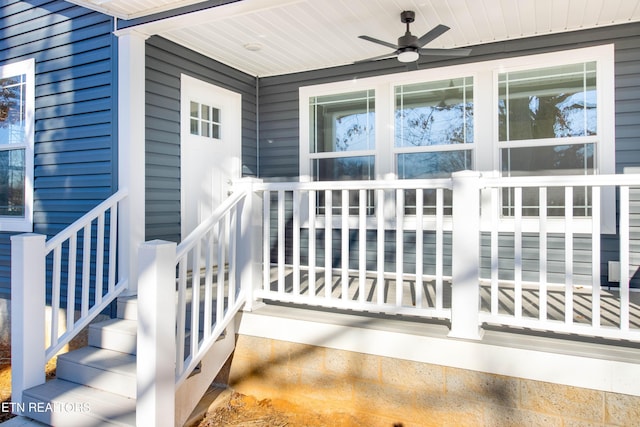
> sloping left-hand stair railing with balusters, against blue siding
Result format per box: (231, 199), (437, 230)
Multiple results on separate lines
(45, 189), (128, 360)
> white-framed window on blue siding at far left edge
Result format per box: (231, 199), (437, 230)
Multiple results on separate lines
(0, 60), (35, 231)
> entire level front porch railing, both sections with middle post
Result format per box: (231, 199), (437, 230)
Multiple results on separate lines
(255, 172), (640, 341)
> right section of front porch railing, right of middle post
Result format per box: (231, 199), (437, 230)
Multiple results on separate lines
(480, 175), (640, 341)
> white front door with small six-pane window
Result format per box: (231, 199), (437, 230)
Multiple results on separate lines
(180, 74), (242, 239)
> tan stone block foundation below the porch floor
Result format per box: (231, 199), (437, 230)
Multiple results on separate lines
(225, 335), (640, 427)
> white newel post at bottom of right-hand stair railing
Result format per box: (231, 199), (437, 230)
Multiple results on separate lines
(136, 240), (176, 427)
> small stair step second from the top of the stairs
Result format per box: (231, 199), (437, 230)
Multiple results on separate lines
(89, 319), (138, 354)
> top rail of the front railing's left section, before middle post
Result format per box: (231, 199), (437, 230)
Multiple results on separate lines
(253, 178), (452, 191)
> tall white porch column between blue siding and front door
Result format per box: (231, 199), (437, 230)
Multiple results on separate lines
(116, 30), (147, 295)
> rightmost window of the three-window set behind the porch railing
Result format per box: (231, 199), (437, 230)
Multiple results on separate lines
(498, 61), (599, 216)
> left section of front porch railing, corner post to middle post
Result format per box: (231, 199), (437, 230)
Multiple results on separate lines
(256, 179), (452, 318)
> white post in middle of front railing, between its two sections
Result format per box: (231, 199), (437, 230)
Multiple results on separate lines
(449, 171), (483, 340)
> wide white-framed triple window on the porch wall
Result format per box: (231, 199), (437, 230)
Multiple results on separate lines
(300, 45), (615, 233)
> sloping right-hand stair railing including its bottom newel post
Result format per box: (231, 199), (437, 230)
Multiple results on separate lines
(136, 179), (261, 426)
